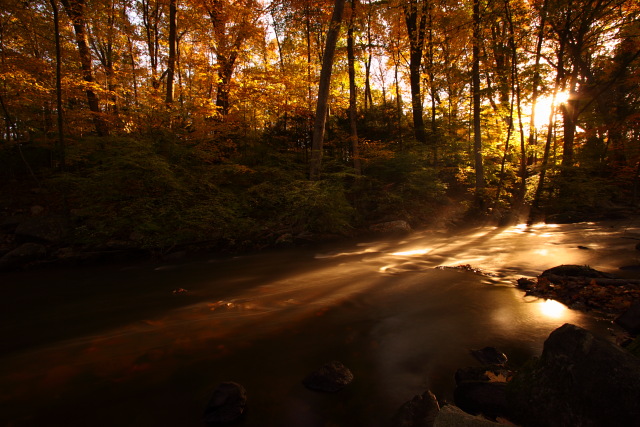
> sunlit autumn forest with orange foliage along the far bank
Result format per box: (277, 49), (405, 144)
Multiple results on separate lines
(0, 0), (640, 253)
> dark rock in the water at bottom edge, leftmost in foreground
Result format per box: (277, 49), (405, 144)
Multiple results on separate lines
(204, 382), (247, 426)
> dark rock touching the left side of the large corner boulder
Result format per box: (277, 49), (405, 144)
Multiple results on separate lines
(453, 382), (511, 418)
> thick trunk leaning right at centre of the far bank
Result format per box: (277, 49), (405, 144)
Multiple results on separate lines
(309, 0), (345, 180)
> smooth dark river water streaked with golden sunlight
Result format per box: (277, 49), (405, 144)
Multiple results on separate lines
(0, 220), (640, 427)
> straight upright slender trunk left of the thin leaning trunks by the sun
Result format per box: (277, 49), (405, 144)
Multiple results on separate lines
(471, 0), (484, 193)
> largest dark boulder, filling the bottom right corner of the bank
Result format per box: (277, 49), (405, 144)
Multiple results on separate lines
(508, 324), (640, 427)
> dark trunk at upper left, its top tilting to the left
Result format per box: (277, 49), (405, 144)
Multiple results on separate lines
(61, 0), (109, 136)
